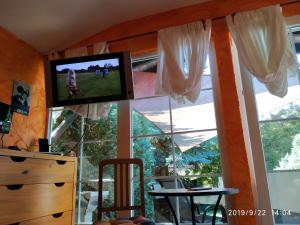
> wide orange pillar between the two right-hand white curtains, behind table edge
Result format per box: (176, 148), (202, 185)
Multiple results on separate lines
(212, 19), (257, 225)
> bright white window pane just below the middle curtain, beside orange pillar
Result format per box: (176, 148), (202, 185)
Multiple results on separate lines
(171, 90), (216, 132)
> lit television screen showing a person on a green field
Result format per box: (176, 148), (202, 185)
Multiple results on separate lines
(56, 58), (122, 101)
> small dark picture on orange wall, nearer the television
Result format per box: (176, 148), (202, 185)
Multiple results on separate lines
(12, 80), (30, 116)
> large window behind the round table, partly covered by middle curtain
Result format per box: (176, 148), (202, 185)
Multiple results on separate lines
(131, 57), (224, 222)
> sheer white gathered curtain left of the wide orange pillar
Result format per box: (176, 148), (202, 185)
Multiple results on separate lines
(156, 20), (211, 102)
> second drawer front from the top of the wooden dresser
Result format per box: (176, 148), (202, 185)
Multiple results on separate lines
(0, 183), (74, 225)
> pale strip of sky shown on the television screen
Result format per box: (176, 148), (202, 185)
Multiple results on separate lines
(56, 58), (119, 71)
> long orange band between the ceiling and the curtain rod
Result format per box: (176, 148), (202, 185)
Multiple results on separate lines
(70, 0), (299, 48)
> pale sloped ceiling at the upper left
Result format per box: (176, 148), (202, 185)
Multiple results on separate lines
(0, 0), (209, 54)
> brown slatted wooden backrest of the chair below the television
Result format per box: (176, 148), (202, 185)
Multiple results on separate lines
(98, 158), (145, 220)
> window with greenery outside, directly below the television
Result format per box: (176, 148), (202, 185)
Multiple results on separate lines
(50, 103), (118, 225)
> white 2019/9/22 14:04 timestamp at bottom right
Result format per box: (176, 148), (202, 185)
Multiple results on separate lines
(228, 209), (291, 216)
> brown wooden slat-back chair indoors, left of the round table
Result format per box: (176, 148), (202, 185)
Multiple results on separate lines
(94, 158), (154, 225)
